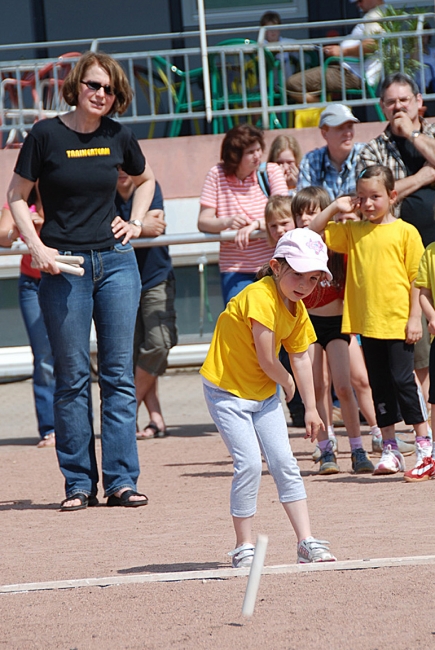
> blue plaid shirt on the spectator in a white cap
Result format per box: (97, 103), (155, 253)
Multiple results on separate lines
(297, 142), (366, 200)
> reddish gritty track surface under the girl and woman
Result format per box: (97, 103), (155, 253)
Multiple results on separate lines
(0, 373), (435, 650)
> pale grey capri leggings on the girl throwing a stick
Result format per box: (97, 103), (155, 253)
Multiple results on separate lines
(203, 382), (307, 517)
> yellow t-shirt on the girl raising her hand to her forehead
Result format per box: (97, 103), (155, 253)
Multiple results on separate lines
(325, 219), (424, 339)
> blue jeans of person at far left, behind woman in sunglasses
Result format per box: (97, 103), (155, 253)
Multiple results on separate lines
(18, 273), (54, 438)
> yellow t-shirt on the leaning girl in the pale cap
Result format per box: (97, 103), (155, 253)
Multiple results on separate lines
(200, 277), (316, 401)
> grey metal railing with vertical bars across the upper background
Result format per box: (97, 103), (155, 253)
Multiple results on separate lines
(0, 13), (435, 146)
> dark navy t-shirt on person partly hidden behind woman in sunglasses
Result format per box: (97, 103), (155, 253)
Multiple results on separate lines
(115, 182), (174, 291)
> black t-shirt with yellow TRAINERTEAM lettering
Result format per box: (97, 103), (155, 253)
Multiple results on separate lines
(15, 117), (145, 251)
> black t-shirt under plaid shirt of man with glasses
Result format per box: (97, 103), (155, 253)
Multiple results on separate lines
(393, 136), (435, 246)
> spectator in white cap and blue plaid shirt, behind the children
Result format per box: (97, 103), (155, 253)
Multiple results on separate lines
(297, 104), (365, 200)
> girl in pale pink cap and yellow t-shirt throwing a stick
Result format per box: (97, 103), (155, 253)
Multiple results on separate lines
(201, 230), (335, 567)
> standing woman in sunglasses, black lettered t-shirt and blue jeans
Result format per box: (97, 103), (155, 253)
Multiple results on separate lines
(8, 52), (155, 511)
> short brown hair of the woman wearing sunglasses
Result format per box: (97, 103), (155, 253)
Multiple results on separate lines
(62, 52), (133, 115)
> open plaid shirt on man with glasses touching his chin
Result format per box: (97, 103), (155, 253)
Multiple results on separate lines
(356, 118), (435, 217)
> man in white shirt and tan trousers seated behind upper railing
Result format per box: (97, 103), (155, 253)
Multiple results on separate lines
(286, 0), (385, 103)
